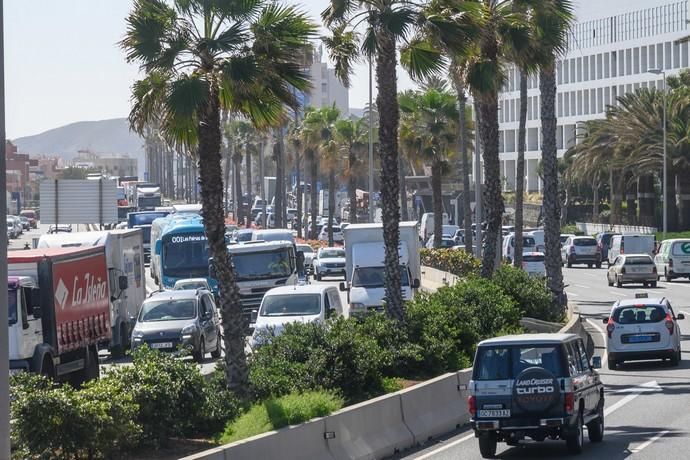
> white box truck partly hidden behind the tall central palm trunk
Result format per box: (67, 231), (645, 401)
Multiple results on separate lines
(340, 222), (421, 314)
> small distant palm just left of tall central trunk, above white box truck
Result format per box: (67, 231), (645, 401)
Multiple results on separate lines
(335, 118), (369, 224)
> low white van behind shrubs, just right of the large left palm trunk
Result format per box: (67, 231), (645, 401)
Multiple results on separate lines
(251, 284), (343, 347)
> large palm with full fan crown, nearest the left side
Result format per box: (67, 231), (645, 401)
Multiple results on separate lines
(121, 0), (316, 397)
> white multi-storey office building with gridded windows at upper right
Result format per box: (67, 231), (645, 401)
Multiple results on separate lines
(492, 0), (690, 192)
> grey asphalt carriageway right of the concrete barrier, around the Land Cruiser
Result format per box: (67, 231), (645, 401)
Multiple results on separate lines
(399, 268), (690, 460)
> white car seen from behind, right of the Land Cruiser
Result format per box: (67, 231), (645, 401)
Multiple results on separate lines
(604, 294), (685, 370)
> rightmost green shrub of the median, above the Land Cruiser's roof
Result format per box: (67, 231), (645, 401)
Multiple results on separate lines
(493, 265), (562, 321)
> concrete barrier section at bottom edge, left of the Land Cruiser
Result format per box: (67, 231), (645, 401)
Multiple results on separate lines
(324, 393), (414, 460)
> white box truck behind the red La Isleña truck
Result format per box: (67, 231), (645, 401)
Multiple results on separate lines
(38, 228), (146, 357)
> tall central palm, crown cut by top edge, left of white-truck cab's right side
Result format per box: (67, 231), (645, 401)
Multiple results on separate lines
(321, 0), (428, 321)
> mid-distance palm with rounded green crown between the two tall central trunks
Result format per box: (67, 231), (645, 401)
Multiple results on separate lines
(399, 88), (459, 248)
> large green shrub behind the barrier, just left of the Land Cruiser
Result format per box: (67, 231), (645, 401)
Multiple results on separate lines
(406, 278), (520, 376)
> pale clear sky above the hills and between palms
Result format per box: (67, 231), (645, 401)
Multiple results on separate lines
(4, 0), (410, 139)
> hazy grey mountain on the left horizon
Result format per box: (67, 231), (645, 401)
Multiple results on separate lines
(12, 118), (144, 172)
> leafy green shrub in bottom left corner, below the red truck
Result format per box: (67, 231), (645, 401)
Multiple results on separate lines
(11, 374), (141, 459)
